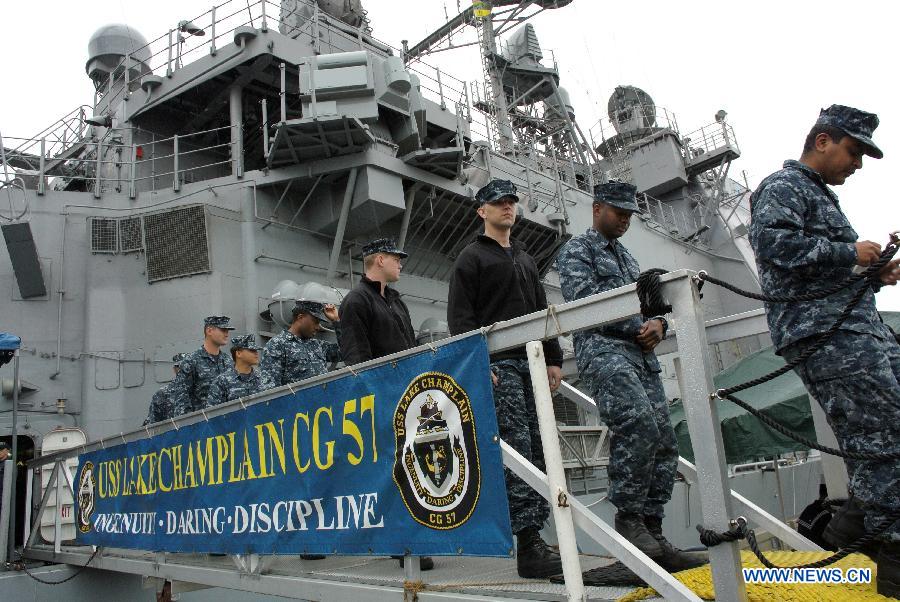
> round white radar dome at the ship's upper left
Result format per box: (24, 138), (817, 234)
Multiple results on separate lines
(84, 23), (150, 85)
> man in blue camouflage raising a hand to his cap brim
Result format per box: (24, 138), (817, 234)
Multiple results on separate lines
(259, 301), (341, 388)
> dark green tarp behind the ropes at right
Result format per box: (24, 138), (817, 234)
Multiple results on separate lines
(670, 312), (900, 464)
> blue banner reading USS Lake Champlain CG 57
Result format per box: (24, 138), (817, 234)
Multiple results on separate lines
(76, 335), (512, 557)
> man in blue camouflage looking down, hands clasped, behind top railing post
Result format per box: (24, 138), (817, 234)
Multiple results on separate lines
(556, 182), (702, 571)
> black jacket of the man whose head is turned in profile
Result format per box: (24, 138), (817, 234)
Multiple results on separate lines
(338, 276), (416, 366)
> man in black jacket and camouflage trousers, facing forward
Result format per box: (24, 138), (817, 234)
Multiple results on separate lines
(447, 180), (562, 578)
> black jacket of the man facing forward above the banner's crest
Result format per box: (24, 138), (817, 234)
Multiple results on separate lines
(448, 234), (562, 366)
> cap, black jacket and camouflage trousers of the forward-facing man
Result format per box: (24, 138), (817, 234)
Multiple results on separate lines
(447, 180), (562, 533)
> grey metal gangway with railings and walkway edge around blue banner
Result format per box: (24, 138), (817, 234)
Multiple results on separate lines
(24, 270), (821, 602)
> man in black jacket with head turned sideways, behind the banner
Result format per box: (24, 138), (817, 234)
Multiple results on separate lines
(338, 238), (434, 571)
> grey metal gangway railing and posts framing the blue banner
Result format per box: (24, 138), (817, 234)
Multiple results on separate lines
(10, 270), (821, 601)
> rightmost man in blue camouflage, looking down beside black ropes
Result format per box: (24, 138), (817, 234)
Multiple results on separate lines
(750, 105), (900, 597)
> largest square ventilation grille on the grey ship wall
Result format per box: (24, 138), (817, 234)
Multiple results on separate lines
(144, 205), (210, 282)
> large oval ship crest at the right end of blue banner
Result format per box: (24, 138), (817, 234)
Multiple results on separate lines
(394, 372), (481, 529)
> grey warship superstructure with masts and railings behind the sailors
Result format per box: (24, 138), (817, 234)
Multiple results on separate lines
(0, 0), (802, 596)
